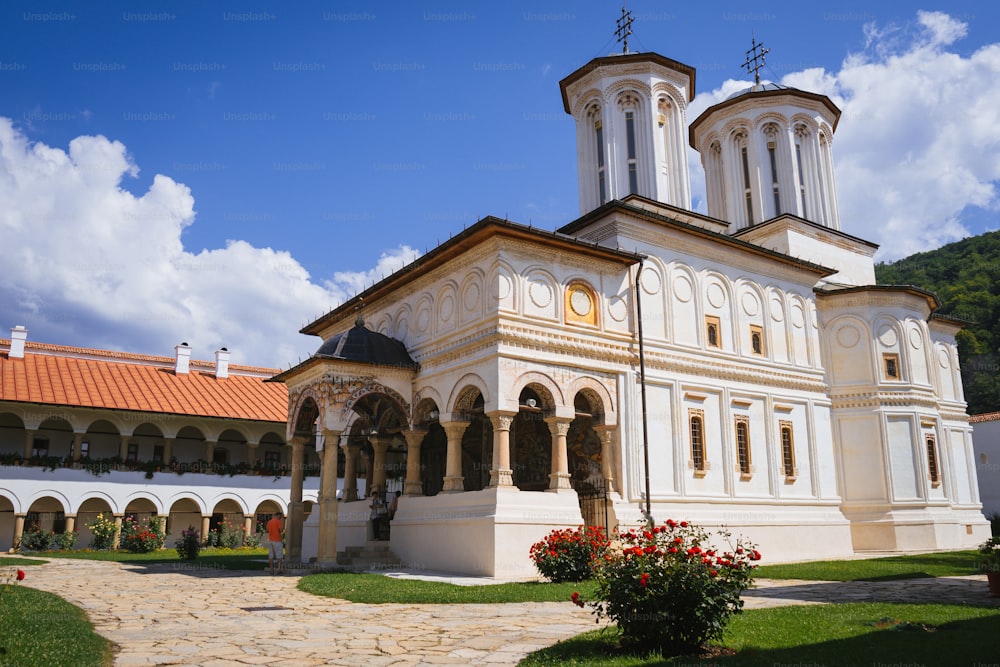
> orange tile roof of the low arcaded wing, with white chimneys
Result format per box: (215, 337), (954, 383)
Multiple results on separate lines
(0, 339), (288, 423)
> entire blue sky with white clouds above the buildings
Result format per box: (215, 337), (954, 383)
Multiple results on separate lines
(0, 1), (1000, 366)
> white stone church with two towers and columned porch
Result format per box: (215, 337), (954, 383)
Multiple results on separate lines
(274, 44), (989, 576)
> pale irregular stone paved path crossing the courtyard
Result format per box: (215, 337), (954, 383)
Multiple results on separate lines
(11, 559), (1000, 667)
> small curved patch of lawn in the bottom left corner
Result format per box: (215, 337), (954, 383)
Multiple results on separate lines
(0, 588), (114, 667)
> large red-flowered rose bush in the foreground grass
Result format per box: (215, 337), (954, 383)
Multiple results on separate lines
(572, 520), (760, 656)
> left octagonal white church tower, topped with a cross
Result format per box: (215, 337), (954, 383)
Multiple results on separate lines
(559, 10), (695, 215)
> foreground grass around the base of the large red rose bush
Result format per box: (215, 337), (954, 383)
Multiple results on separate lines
(521, 603), (1000, 667)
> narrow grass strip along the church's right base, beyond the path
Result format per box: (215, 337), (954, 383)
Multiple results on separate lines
(756, 551), (979, 581)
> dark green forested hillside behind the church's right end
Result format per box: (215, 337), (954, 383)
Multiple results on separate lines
(875, 232), (1000, 414)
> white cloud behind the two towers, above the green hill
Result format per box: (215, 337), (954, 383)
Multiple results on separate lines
(689, 12), (1000, 260)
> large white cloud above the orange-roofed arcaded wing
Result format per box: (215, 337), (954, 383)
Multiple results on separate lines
(0, 118), (418, 366)
